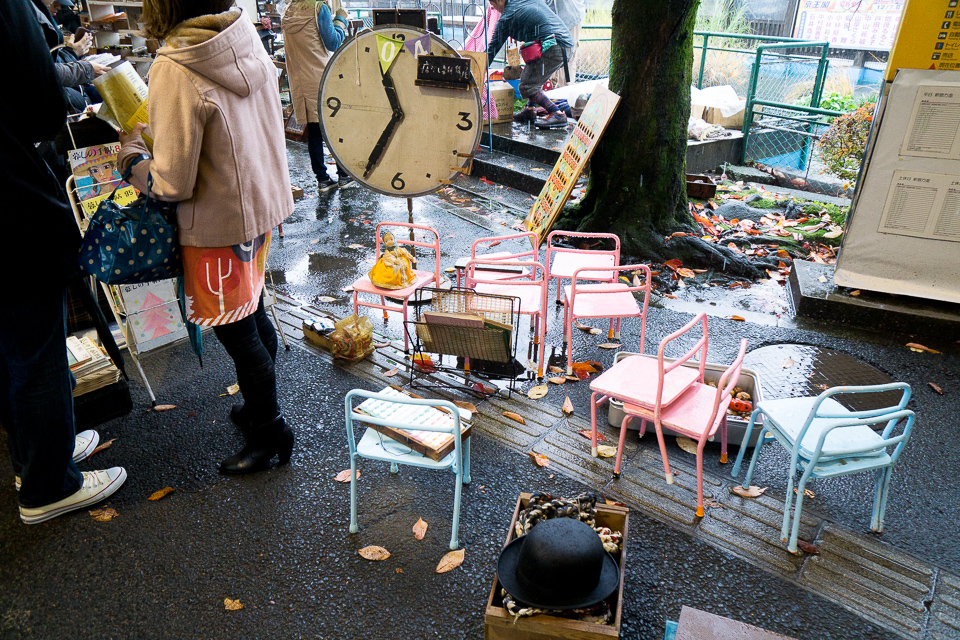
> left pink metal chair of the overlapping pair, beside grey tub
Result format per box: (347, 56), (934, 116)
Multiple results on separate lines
(590, 313), (707, 484)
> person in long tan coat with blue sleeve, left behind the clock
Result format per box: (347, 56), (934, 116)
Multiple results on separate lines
(280, 0), (353, 193)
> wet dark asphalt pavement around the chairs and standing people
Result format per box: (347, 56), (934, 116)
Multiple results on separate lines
(0, 144), (960, 639)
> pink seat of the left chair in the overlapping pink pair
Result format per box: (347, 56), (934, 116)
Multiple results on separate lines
(577, 356), (700, 408)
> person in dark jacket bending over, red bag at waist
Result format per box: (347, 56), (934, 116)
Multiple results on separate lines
(487, 0), (573, 129)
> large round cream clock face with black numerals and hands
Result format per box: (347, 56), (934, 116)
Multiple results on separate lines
(318, 25), (482, 197)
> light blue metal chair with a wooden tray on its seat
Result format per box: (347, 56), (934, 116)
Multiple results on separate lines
(344, 389), (470, 549)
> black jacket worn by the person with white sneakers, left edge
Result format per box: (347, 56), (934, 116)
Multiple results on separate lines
(0, 0), (80, 288)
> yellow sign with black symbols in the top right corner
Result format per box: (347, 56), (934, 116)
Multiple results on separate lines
(886, 0), (960, 82)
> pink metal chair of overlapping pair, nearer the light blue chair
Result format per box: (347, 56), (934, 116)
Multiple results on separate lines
(617, 339), (747, 518)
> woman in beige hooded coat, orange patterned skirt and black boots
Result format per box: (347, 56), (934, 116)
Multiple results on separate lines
(118, 0), (294, 473)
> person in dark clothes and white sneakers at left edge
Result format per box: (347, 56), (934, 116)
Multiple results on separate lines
(0, 0), (127, 524)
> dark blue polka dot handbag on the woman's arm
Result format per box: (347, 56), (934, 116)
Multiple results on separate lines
(80, 174), (183, 284)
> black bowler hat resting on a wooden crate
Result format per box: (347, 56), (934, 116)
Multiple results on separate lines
(497, 518), (620, 610)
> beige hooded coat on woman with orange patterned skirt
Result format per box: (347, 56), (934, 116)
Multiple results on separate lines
(118, 8), (293, 247)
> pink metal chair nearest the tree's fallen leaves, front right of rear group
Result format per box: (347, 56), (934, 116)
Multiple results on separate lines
(558, 264), (653, 376)
